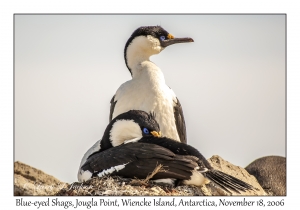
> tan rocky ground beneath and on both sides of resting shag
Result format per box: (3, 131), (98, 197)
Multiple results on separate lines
(14, 156), (284, 196)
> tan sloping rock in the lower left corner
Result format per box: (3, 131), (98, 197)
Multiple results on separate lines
(14, 161), (67, 196)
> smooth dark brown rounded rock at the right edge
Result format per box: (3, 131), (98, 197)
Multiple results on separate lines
(245, 156), (286, 196)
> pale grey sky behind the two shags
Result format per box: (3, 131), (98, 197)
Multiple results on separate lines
(15, 15), (286, 182)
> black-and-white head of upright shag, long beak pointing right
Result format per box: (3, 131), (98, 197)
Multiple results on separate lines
(124, 26), (194, 74)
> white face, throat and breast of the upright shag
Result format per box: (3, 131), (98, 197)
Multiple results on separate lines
(112, 36), (179, 143)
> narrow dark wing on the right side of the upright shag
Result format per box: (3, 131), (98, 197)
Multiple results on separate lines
(174, 98), (187, 144)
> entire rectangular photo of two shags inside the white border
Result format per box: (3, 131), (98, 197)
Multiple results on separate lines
(13, 13), (287, 197)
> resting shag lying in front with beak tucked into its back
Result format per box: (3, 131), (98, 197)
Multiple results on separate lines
(79, 110), (253, 192)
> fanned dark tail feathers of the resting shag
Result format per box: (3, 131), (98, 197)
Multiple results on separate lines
(203, 169), (254, 193)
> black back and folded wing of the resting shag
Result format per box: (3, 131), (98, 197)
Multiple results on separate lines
(81, 143), (198, 179)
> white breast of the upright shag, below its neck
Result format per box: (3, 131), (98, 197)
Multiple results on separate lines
(112, 61), (180, 141)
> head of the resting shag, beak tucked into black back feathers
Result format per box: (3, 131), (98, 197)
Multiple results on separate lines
(101, 110), (161, 149)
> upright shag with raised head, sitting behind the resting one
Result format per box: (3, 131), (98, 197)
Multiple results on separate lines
(109, 26), (194, 143)
